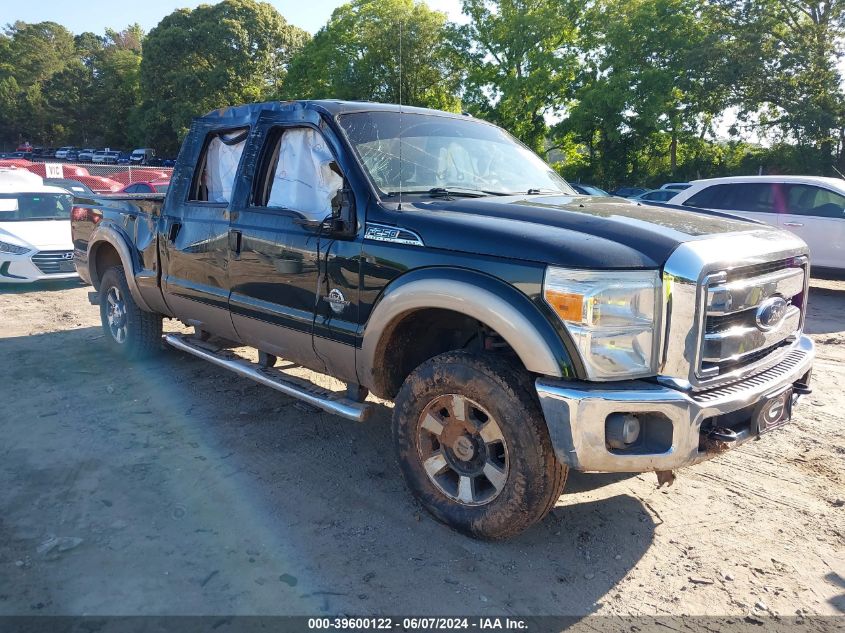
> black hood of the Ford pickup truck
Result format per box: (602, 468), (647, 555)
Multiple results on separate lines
(399, 195), (760, 269)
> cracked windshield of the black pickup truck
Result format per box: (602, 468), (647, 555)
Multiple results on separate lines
(340, 112), (575, 196)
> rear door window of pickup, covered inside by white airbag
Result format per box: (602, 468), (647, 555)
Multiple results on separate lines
(189, 128), (249, 203)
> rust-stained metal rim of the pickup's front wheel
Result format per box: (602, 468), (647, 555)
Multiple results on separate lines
(417, 394), (510, 506)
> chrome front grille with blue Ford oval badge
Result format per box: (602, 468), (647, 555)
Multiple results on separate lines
(696, 258), (807, 380)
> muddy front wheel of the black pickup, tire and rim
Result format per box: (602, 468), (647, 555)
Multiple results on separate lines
(393, 352), (568, 539)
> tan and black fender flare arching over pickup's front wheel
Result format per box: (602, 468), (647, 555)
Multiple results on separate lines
(357, 267), (575, 384)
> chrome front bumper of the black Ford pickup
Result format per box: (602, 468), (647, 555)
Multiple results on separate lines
(536, 336), (815, 472)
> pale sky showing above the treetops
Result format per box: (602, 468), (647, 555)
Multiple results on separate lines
(0, 0), (461, 35)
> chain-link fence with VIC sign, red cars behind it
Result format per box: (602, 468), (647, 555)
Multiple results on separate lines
(0, 159), (173, 193)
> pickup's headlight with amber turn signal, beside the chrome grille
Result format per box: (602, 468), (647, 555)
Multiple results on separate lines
(543, 268), (660, 380)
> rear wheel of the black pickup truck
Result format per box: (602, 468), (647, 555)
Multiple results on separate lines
(100, 266), (162, 360)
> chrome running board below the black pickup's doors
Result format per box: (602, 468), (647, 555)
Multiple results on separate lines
(164, 334), (372, 422)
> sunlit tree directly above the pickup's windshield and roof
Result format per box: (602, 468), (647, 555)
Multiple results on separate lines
(282, 0), (460, 110)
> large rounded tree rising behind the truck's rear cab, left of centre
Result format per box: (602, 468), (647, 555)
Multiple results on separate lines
(133, 0), (308, 153)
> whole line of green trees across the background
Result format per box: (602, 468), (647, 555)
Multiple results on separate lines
(0, 0), (845, 181)
